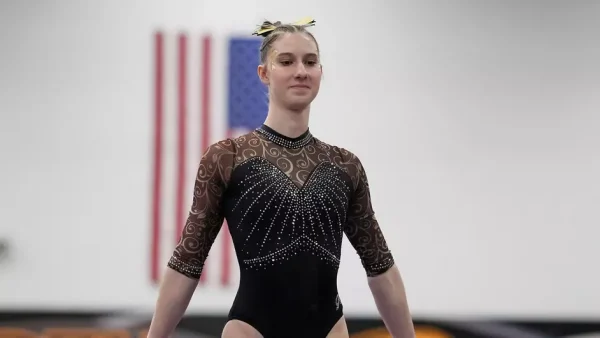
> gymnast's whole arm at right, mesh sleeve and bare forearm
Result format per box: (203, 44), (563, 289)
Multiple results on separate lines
(344, 157), (415, 338)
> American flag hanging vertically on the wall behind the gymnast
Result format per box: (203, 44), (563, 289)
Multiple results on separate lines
(150, 31), (268, 286)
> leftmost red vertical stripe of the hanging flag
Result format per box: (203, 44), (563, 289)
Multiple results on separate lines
(150, 33), (164, 282)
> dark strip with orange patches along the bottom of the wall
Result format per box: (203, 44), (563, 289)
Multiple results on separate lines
(0, 313), (600, 338)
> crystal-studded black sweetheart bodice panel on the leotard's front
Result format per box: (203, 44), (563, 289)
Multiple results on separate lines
(230, 157), (351, 269)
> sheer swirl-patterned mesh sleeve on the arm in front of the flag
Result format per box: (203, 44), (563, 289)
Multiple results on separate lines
(168, 141), (234, 279)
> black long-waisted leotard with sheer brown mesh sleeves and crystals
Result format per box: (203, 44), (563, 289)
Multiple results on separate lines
(168, 125), (394, 338)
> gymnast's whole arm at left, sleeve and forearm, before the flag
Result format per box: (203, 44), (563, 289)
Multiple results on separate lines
(148, 141), (233, 338)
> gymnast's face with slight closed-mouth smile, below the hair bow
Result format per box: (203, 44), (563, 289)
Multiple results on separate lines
(258, 33), (323, 111)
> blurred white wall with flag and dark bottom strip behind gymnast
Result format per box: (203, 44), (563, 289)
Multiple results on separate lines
(0, 0), (600, 338)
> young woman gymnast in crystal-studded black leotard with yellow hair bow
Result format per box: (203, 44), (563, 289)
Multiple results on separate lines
(149, 19), (415, 338)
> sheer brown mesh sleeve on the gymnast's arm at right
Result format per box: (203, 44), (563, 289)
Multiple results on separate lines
(344, 151), (394, 277)
